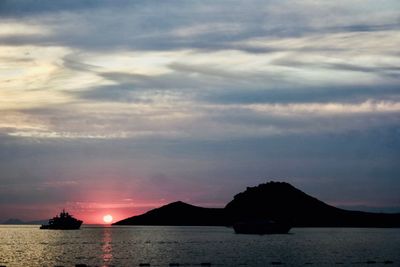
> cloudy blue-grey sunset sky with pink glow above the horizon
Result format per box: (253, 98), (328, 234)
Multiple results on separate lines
(0, 0), (400, 223)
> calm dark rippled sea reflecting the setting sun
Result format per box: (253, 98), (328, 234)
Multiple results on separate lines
(0, 225), (400, 266)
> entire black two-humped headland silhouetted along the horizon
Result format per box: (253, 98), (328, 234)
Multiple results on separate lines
(114, 182), (400, 227)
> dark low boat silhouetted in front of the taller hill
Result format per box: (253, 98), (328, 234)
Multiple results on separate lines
(233, 220), (292, 235)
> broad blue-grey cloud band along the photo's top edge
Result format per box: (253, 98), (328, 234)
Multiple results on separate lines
(0, 0), (398, 53)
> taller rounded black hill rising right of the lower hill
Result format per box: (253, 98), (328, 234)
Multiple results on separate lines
(225, 182), (400, 227)
